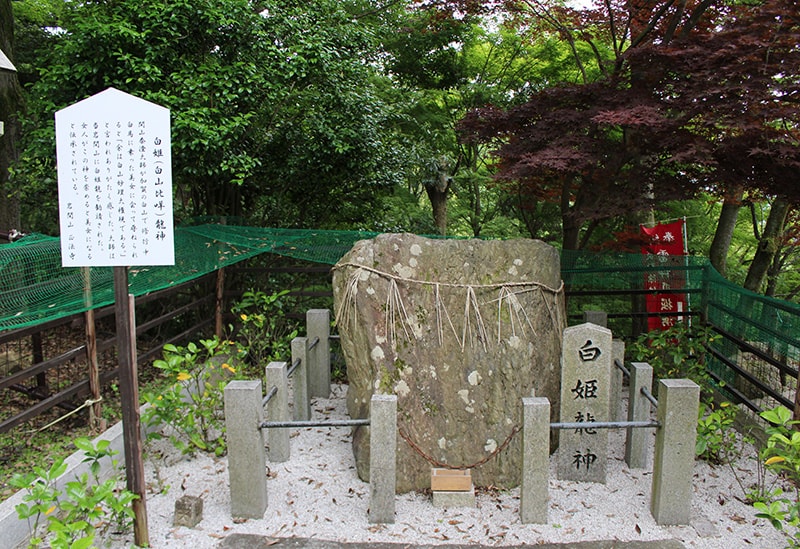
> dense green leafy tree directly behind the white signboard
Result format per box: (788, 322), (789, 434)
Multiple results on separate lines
(12, 0), (397, 230)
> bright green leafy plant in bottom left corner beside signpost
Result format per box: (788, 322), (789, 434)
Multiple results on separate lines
(10, 439), (137, 549)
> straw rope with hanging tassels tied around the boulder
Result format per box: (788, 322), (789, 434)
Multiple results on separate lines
(333, 263), (564, 351)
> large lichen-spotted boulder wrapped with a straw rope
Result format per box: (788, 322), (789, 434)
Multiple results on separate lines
(333, 234), (566, 493)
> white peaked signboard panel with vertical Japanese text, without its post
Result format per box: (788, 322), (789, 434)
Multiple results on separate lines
(56, 88), (175, 267)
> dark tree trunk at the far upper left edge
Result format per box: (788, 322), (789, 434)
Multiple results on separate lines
(0, 0), (22, 231)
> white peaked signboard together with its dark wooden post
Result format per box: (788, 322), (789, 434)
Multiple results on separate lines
(56, 88), (175, 547)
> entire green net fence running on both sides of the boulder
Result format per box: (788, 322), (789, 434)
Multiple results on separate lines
(0, 224), (800, 394)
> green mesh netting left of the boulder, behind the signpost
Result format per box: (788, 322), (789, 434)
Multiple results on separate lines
(0, 225), (377, 330)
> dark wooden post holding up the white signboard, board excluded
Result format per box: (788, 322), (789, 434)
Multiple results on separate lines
(114, 267), (150, 547)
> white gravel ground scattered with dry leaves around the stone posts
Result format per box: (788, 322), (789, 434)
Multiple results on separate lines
(106, 385), (786, 549)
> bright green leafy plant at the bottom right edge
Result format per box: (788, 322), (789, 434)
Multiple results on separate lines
(753, 406), (800, 547)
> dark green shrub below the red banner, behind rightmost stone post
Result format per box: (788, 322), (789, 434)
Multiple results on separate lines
(631, 323), (721, 395)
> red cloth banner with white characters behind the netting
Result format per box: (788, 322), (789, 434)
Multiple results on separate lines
(641, 220), (687, 330)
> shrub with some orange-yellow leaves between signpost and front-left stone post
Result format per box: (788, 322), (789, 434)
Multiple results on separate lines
(142, 337), (244, 456)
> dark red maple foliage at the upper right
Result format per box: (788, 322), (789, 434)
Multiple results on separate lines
(464, 0), (800, 248)
